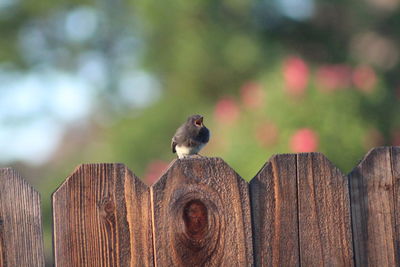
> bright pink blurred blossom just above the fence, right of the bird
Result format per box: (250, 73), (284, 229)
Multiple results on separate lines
(290, 128), (319, 153)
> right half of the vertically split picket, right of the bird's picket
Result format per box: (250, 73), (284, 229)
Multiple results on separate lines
(297, 153), (353, 266)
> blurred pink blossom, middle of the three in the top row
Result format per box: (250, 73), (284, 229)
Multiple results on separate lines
(316, 64), (351, 91)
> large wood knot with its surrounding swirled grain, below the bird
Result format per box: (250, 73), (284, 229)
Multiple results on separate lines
(169, 185), (225, 266)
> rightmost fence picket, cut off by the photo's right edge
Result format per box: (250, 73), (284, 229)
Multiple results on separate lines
(349, 147), (400, 266)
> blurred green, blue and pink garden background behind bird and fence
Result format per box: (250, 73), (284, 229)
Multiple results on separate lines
(0, 0), (400, 265)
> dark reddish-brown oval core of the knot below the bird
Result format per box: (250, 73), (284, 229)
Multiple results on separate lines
(182, 199), (208, 240)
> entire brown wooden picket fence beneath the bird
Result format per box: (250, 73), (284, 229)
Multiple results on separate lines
(0, 147), (400, 267)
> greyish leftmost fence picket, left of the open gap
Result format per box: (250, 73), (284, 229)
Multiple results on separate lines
(0, 168), (44, 267)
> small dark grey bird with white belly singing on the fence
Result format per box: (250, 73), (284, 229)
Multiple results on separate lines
(171, 115), (210, 159)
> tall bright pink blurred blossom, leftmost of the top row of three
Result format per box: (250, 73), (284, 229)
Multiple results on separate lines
(283, 56), (309, 95)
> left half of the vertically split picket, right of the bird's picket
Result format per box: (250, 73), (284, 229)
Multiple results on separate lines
(250, 154), (300, 266)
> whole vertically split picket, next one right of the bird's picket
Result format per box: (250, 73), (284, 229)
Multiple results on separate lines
(250, 153), (353, 266)
